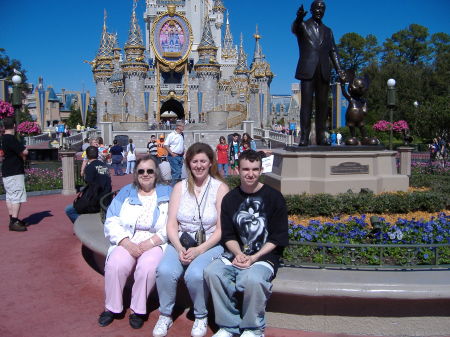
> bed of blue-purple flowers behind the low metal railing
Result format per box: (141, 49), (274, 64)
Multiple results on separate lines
(284, 213), (450, 269)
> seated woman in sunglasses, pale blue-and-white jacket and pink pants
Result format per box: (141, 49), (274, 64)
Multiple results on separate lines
(98, 155), (172, 329)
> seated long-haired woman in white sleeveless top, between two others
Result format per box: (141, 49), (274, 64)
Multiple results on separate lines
(153, 143), (228, 337)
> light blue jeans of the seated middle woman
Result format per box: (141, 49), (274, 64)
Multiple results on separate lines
(156, 245), (223, 318)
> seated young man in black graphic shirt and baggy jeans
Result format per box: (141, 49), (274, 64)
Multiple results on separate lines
(204, 150), (288, 337)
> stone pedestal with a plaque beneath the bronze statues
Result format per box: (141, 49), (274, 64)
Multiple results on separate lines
(265, 146), (409, 195)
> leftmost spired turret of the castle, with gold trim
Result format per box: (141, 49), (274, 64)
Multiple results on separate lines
(89, 11), (113, 122)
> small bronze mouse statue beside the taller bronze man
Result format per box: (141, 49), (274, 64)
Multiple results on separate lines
(342, 73), (379, 145)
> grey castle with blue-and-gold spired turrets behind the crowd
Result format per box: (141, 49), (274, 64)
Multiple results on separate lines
(89, 0), (274, 130)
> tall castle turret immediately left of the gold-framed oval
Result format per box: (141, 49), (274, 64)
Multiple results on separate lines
(121, 0), (148, 122)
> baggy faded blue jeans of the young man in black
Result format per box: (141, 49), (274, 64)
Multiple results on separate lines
(205, 259), (273, 334)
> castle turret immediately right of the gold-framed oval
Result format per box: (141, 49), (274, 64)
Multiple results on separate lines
(194, 17), (220, 121)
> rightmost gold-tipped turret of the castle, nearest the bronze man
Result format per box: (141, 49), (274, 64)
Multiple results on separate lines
(250, 26), (274, 126)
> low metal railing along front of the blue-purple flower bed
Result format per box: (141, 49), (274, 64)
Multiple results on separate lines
(283, 241), (450, 270)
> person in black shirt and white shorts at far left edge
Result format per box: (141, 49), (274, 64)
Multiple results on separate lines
(1, 117), (28, 232)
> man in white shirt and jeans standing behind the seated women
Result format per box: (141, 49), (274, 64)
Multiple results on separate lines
(164, 121), (184, 185)
